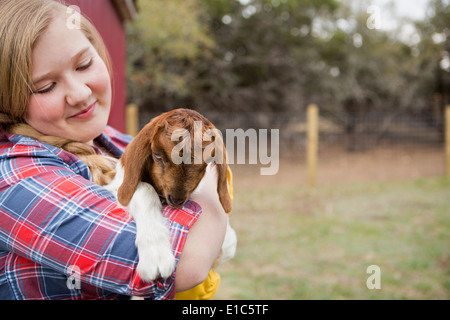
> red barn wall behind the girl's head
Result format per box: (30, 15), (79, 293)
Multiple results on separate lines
(65, 0), (126, 132)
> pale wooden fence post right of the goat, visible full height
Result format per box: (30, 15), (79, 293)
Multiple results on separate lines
(307, 104), (319, 187)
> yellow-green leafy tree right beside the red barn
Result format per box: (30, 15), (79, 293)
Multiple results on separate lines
(127, 0), (214, 111)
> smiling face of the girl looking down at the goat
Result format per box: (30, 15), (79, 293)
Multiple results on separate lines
(25, 18), (111, 144)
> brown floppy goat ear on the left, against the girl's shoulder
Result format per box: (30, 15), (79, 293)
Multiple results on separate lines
(117, 121), (155, 206)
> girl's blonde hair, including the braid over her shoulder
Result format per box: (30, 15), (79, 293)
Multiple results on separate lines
(0, 0), (114, 185)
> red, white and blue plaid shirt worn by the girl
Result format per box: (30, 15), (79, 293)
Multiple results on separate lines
(0, 127), (201, 300)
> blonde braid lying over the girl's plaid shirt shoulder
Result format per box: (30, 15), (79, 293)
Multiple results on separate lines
(7, 123), (117, 186)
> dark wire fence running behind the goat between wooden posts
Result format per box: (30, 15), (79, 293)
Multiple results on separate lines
(140, 111), (445, 157)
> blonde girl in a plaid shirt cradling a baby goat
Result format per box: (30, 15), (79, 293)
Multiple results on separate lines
(0, 0), (226, 299)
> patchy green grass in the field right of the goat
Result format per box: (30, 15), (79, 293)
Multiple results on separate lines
(216, 178), (450, 299)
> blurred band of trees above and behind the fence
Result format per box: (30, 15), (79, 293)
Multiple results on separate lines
(127, 0), (450, 127)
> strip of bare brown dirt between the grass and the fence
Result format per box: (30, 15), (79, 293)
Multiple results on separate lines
(231, 146), (445, 189)
